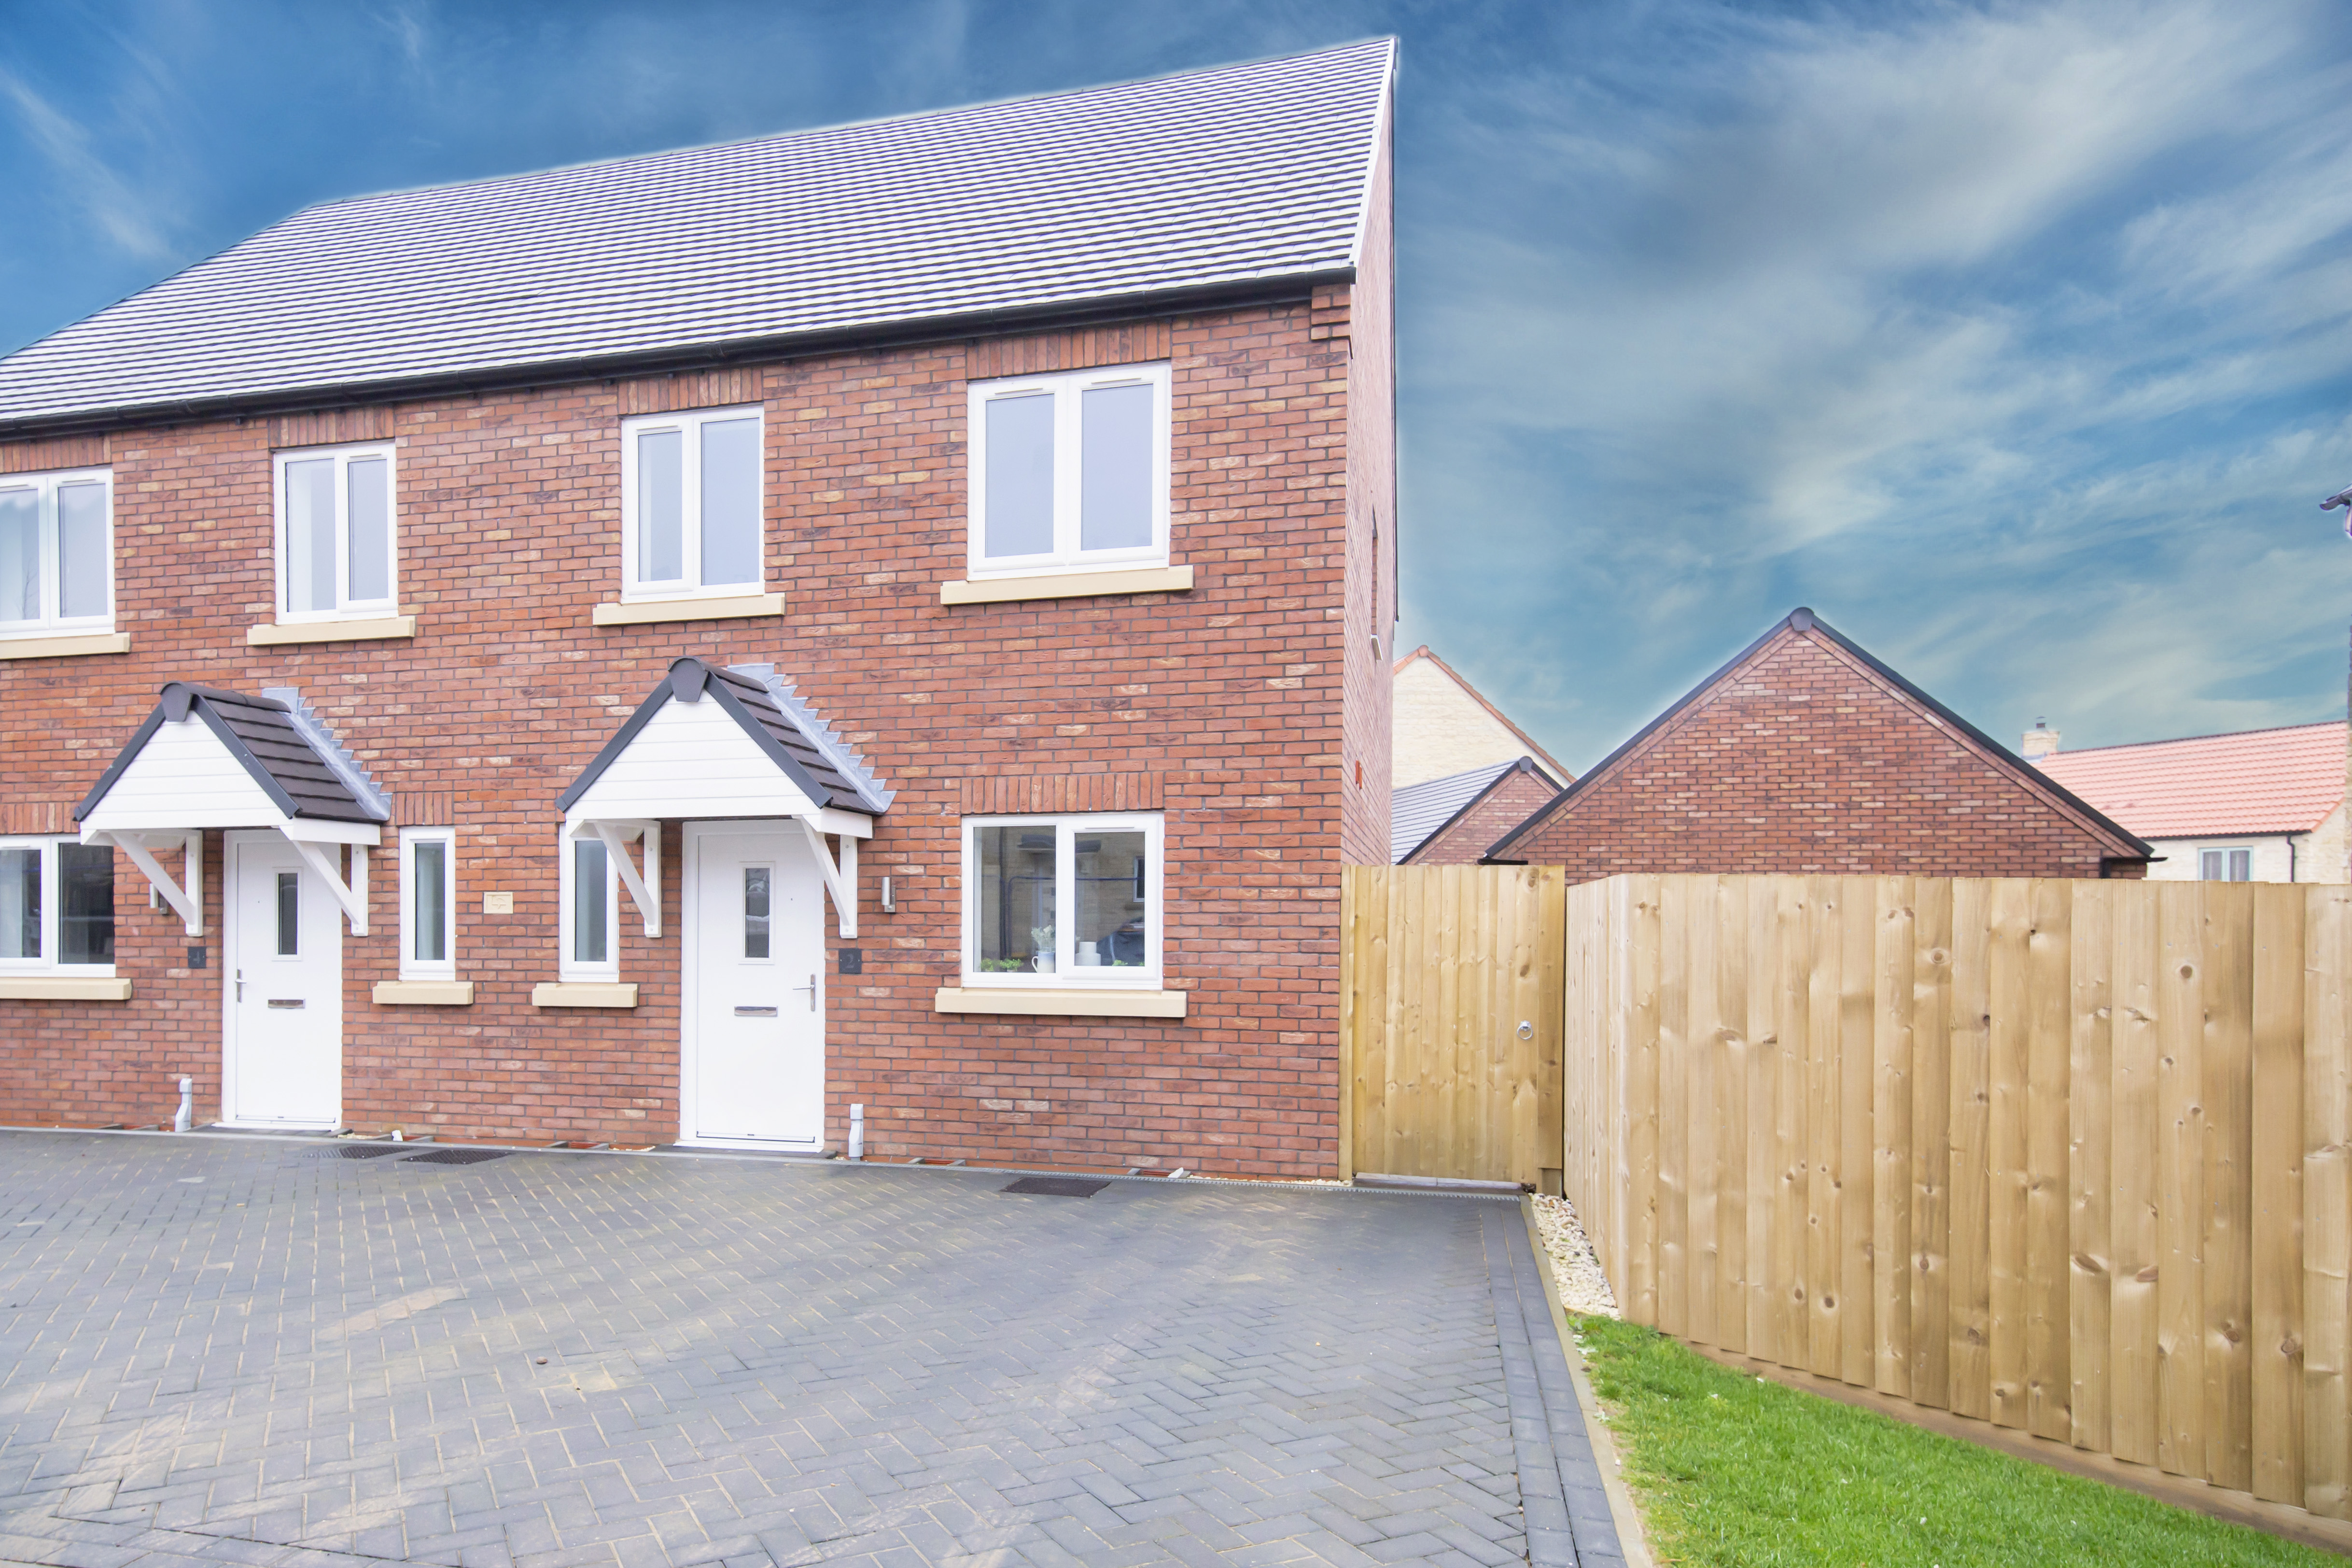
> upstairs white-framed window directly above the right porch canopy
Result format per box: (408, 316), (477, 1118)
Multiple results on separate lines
(621, 409), (767, 600)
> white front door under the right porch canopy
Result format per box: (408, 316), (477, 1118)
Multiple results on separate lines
(677, 823), (826, 1152)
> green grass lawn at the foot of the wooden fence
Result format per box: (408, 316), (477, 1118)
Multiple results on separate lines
(1569, 1316), (2343, 1568)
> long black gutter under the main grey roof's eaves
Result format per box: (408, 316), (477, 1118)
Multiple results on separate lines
(0, 266), (1355, 440)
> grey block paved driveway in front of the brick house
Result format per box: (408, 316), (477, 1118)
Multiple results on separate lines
(0, 1133), (1621, 1568)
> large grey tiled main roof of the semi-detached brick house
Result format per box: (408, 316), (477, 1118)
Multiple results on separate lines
(0, 40), (1395, 430)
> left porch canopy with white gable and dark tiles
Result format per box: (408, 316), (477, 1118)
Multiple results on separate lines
(73, 682), (393, 936)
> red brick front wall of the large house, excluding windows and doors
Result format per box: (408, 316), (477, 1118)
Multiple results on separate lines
(0, 301), (1387, 1176)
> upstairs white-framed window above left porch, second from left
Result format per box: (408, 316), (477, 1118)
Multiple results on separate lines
(278, 444), (400, 623)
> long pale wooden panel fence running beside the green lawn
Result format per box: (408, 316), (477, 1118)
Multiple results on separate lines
(1562, 877), (2352, 1519)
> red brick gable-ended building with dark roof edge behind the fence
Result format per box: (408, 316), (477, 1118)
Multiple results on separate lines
(1486, 609), (2155, 882)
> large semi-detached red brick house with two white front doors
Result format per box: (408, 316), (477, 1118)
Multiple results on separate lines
(0, 40), (1397, 1173)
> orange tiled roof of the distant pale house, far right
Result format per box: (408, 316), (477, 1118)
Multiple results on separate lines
(2042, 722), (2345, 839)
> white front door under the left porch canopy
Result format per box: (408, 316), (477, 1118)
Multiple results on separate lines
(221, 832), (343, 1128)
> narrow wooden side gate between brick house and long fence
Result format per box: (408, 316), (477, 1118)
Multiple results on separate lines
(1338, 865), (1567, 1192)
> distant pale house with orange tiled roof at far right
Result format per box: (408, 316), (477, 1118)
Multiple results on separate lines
(2025, 719), (2352, 882)
